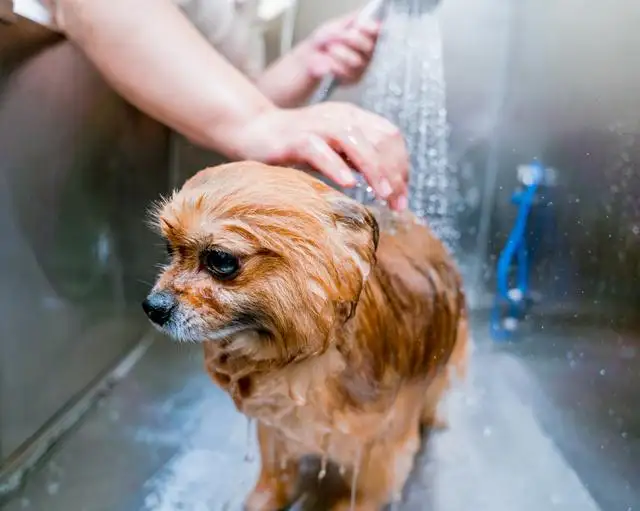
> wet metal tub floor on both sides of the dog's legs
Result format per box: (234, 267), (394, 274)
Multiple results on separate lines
(6, 321), (640, 511)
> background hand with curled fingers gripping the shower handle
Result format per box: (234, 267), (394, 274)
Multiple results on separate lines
(301, 12), (380, 85)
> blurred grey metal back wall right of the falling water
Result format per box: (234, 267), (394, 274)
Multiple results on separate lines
(296, 0), (640, 316)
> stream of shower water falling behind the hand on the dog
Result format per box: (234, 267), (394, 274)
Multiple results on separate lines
(355, 0), (462, 254)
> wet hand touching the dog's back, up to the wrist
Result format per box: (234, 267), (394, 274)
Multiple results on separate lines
(231, 102), (409, 210)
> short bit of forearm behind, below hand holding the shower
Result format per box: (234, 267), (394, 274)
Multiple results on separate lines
(256, 43), (320, 108)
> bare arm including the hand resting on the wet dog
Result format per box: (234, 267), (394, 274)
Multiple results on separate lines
(55, 0), (408, 208)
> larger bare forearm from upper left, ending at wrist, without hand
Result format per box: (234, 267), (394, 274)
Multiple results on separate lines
(57, 0), (274, 157)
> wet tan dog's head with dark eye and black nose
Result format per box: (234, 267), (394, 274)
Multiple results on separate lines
(143, 162), (378, 363)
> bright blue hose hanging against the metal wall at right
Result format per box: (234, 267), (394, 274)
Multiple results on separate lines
(490, 165), (544, 341)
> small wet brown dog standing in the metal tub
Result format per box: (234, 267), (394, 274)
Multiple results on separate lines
(144, 162), (467, 511)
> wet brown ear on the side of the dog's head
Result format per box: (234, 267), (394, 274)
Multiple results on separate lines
(328, 193), (380, 320)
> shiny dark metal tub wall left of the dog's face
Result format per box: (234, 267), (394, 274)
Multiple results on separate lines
(0, 22), (169, 460)
